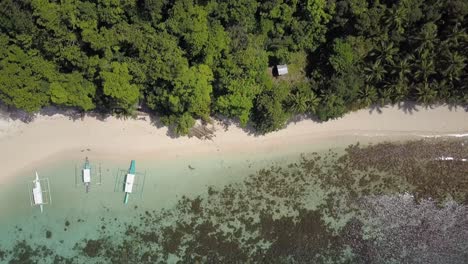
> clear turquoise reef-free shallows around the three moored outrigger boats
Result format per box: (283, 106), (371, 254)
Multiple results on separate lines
(0, 148), (310, 256)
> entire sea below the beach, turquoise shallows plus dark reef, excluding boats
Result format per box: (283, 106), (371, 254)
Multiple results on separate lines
(0, 137), (468, 264)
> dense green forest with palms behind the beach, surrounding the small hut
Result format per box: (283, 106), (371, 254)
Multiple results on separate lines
(0, 0), (468, 134)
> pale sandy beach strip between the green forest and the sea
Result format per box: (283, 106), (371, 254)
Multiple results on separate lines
(0, 106), (468, 181)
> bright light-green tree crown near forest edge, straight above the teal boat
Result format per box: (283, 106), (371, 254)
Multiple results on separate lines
(100, 62), (139, 113)
